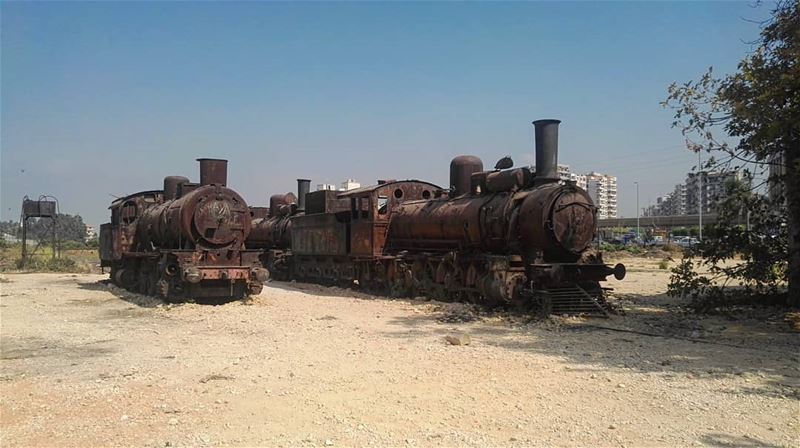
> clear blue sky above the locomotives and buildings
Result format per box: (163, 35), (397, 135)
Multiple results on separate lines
(0, 2), (769, 224)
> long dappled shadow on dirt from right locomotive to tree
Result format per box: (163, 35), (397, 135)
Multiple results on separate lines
(380, 294), (800, 400)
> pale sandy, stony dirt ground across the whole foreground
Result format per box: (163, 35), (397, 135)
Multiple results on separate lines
(0, 260), (800, 447)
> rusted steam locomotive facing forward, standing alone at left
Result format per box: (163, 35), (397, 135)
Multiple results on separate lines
(100, 159), (269, 301)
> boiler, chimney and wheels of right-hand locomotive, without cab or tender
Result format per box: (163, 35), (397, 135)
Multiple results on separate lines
(387, 120), (625, 312)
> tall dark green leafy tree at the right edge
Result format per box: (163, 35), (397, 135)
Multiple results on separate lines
(664, 0), (800, 306)
